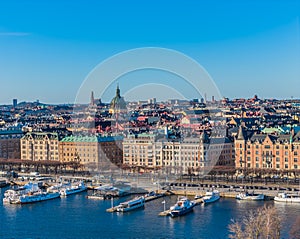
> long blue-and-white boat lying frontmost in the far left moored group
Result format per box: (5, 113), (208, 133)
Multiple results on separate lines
(11, 190), (60, 204)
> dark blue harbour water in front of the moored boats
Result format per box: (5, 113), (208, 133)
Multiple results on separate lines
(0, 189), (300, 239)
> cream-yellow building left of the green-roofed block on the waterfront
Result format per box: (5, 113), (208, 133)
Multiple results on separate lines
(21, 132), (59, 161)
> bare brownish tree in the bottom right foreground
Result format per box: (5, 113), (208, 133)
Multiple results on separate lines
(229, 206), (281, 239)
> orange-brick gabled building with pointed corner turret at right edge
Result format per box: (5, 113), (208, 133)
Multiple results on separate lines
(235, 126), (300, 171)
